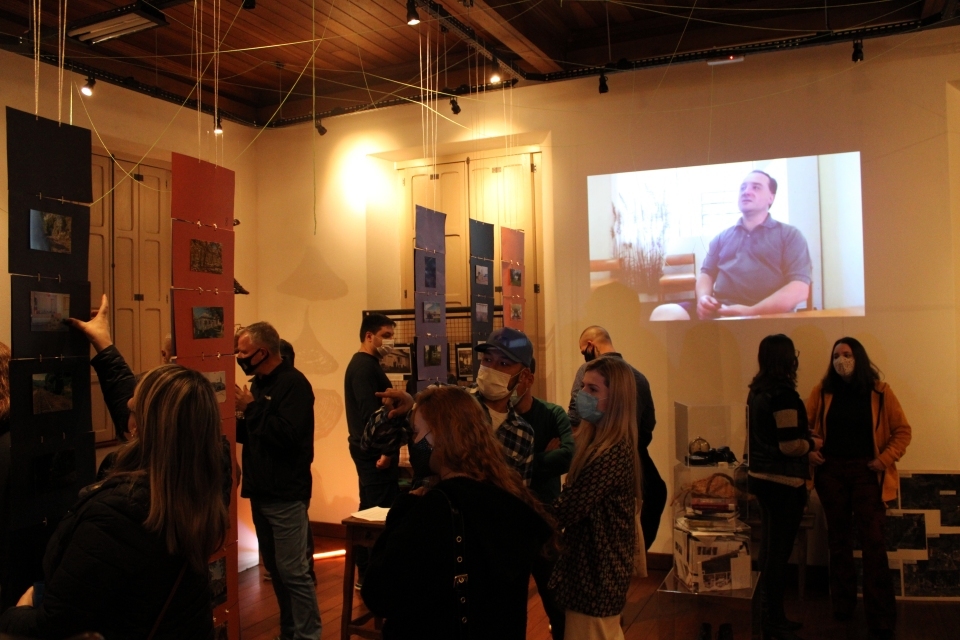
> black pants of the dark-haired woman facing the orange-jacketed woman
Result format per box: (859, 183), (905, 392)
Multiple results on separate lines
(750, 477), (807, 628)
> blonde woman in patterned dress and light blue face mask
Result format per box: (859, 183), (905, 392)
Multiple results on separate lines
(550, 358), (643, 640)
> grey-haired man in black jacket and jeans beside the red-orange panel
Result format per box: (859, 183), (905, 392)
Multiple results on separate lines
(236, 322), (321, 640)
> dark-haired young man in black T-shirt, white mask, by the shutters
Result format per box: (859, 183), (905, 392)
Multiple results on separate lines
(343, 313), (400, 589)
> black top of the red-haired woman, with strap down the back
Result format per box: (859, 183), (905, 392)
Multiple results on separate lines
(361, 478), (550, 640)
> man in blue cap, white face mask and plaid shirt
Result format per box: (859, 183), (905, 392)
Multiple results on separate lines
(471, 327), (535, 487)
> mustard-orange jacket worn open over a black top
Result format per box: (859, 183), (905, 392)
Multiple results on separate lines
(807, 382), (912, 502)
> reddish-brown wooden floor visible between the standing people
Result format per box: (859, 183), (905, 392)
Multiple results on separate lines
(239, 538), (960, 640)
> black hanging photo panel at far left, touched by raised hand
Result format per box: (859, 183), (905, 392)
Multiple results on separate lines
(0, 107), (99, 536)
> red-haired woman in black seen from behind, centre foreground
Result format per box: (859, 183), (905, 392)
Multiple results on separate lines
(361, 386), (551, 640)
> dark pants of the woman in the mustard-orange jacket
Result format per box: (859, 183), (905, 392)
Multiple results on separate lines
(816, 458), (897, 629)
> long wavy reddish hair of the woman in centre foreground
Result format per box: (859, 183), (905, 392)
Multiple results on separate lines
(410, 386), (553, 526)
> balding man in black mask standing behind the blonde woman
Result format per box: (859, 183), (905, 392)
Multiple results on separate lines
(567, 326), (667, 549)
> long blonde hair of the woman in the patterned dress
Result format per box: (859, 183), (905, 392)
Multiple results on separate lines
(567, 358), (642, 505)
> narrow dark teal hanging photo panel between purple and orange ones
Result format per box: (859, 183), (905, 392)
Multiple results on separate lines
(470, 219), (495, 377)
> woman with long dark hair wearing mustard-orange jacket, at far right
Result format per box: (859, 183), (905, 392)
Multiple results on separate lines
(807, 337), (912, 638)
